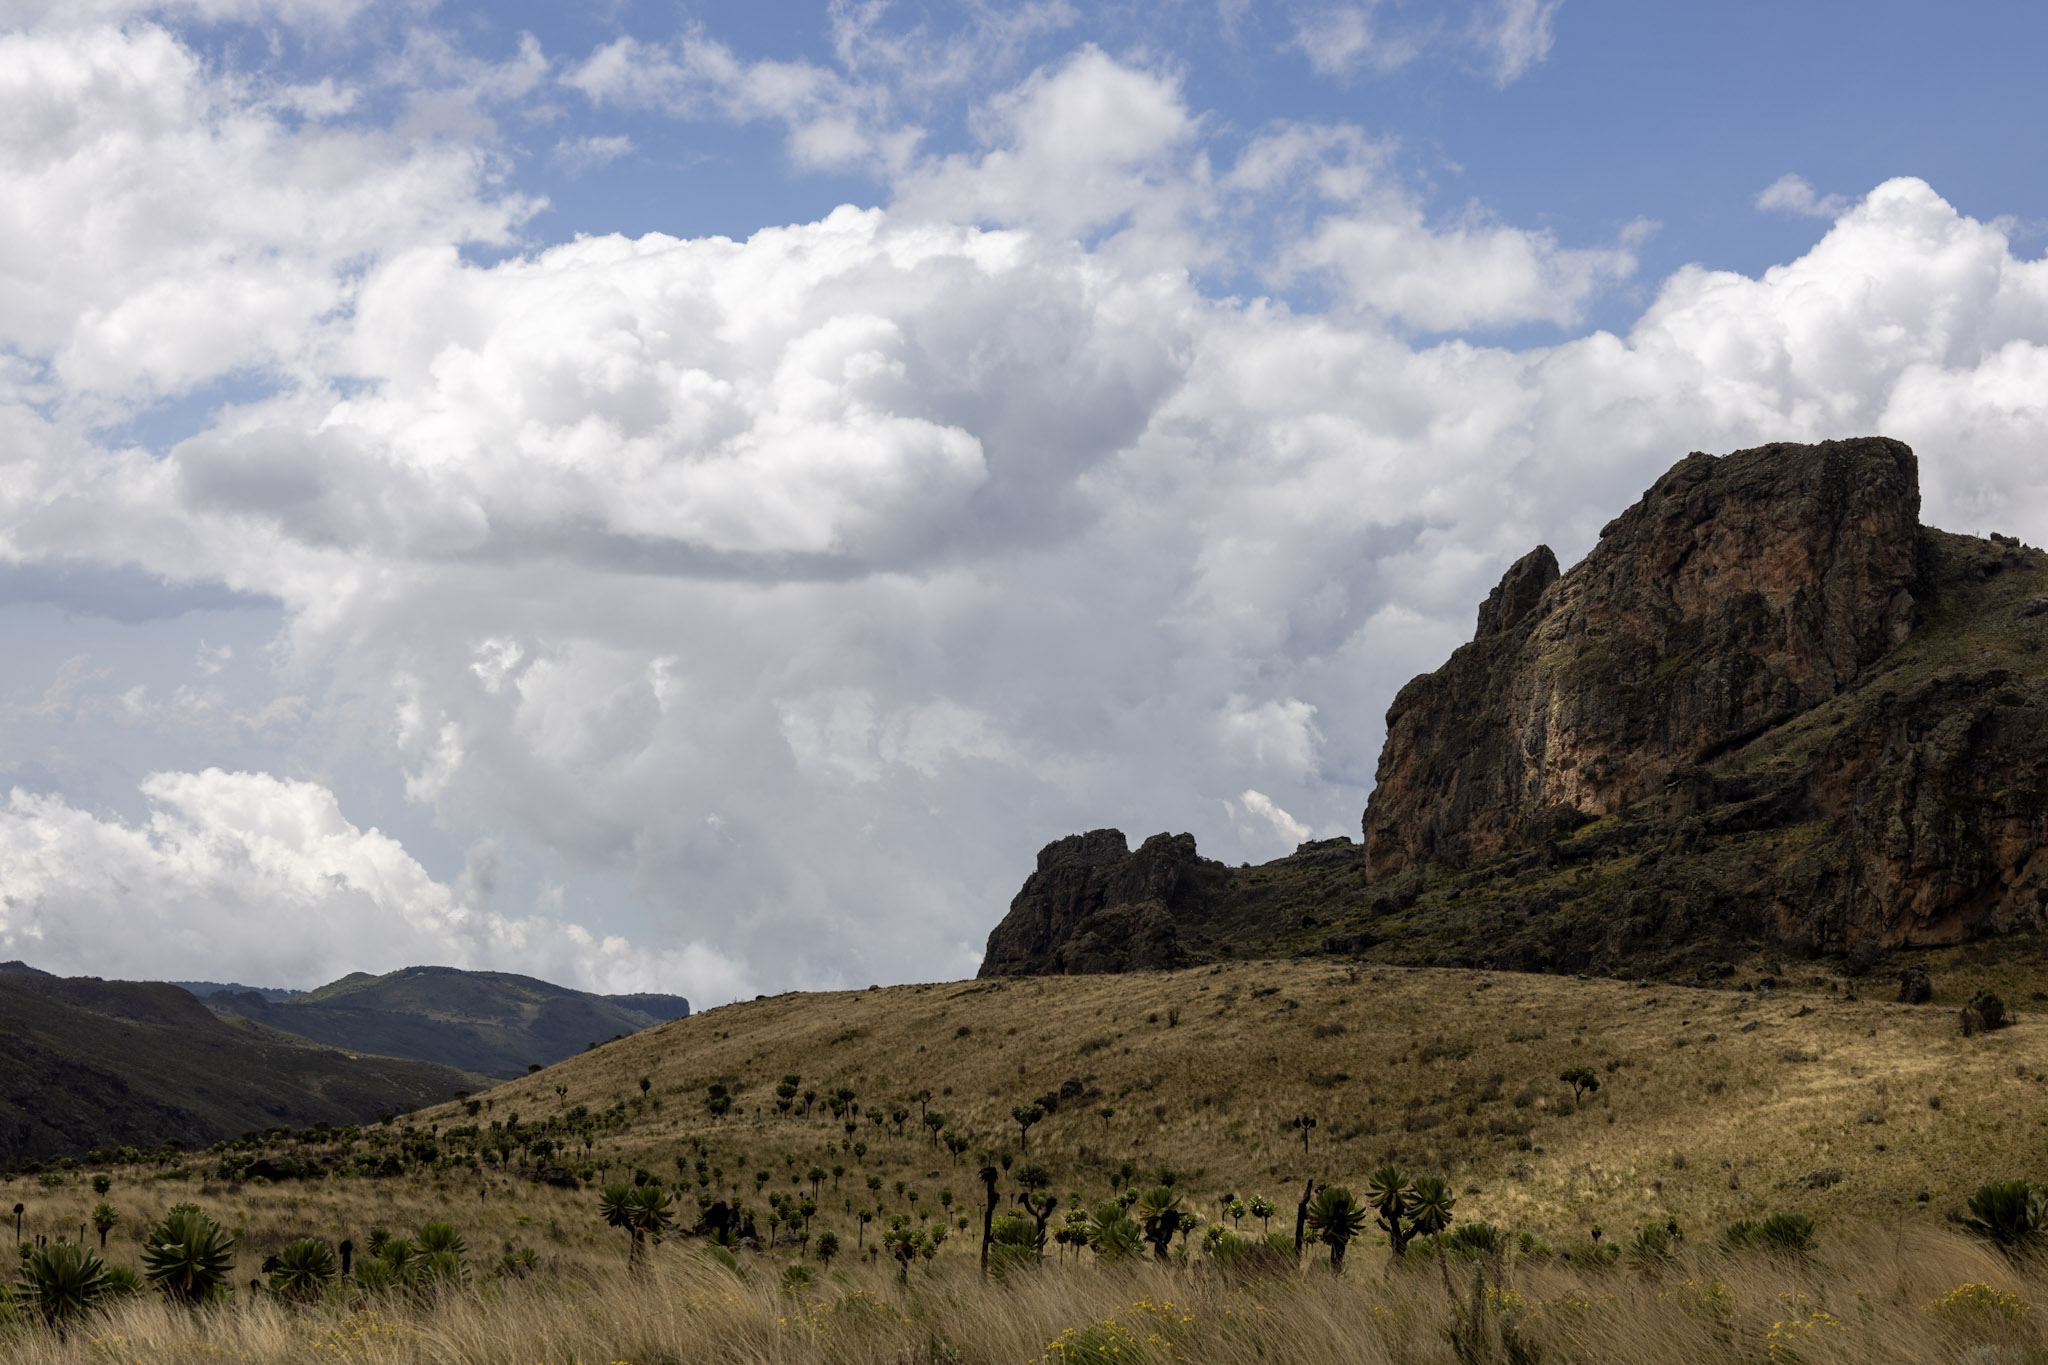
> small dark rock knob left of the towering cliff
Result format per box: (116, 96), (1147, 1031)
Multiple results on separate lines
(979, 829), (1225, 976)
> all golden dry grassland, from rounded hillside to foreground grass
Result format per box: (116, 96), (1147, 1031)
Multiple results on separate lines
(0, 960), (2048, 1365)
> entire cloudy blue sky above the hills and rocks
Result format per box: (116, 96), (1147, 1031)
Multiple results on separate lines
(0, 0), (2048, 1005)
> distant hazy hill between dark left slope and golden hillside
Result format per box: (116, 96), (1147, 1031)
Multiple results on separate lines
(207, 966), (690, 1076)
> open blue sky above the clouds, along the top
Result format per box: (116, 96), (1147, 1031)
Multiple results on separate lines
(380, 0), (2048, 304)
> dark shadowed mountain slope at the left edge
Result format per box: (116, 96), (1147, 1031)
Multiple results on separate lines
(0, 970), (479, 1162)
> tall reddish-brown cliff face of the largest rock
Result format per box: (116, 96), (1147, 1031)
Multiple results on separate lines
(1364, 438), (1919, 880)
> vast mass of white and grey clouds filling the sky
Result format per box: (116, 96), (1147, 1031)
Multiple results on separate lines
(0, 6), (2048, 999)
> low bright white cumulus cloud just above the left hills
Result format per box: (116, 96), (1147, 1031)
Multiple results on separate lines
(0, 767), (741, 993)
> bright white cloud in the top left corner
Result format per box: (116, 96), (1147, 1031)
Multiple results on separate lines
(0, 23), (530, 415)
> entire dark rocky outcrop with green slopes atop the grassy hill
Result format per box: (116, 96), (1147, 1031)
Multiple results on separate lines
(981, 440), (2048, 978)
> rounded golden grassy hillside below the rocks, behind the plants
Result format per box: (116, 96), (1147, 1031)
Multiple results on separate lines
(410, 962), (2048, 1244)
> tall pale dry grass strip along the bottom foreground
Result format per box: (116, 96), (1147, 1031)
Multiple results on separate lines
(0, 1226), (2048, 1365)
